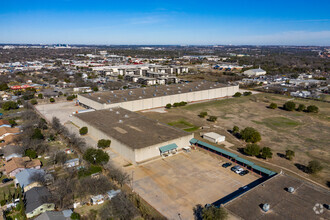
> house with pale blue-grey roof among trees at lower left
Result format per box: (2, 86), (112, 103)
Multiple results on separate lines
(15, 169), (45, 192)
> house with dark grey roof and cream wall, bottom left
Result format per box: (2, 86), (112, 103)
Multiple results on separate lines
(24, 187), (55, 218)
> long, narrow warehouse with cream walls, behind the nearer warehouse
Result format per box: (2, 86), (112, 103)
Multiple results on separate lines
(78, 81), (239, 111)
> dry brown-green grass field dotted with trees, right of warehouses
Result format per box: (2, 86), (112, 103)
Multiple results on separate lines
(143, 93), (330, 185)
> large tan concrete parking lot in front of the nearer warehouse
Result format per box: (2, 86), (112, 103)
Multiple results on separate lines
(125, 150), (258, 219)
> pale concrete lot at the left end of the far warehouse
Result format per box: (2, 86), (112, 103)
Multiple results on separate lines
(36, 102), (85, 124)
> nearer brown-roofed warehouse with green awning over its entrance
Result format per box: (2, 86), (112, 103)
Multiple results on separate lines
(72, 107), (193, 164)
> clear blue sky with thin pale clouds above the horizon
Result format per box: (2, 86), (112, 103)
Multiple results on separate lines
(0, 0), (330, 45)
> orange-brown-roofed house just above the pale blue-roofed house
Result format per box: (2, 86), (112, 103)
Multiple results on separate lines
(5, 157), (41, 177)
